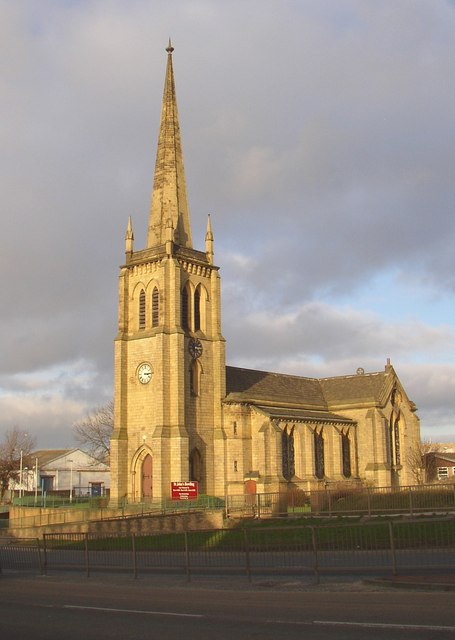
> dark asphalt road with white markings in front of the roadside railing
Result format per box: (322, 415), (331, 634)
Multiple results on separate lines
(0, 574), (455, 640)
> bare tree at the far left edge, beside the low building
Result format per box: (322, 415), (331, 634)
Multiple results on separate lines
(0, 427), (35, 498)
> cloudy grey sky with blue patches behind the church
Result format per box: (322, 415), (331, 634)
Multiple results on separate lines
(0, 0), (455, 448)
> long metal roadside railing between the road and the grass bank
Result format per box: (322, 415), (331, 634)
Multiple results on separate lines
(0, 518), (455, 581)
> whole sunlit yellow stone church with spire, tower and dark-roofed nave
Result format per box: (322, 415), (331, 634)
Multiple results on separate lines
(111, 42), (420, 505)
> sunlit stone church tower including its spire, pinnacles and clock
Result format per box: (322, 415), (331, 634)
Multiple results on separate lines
(111, 41), (226, 504)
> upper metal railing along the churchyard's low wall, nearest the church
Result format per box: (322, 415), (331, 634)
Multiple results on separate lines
(4, 483), (455, 529)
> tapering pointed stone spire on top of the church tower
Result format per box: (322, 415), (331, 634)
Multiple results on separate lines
(147, 39), (192, 248)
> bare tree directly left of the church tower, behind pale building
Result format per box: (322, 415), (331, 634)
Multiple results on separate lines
(73, 400), (114, 462)
